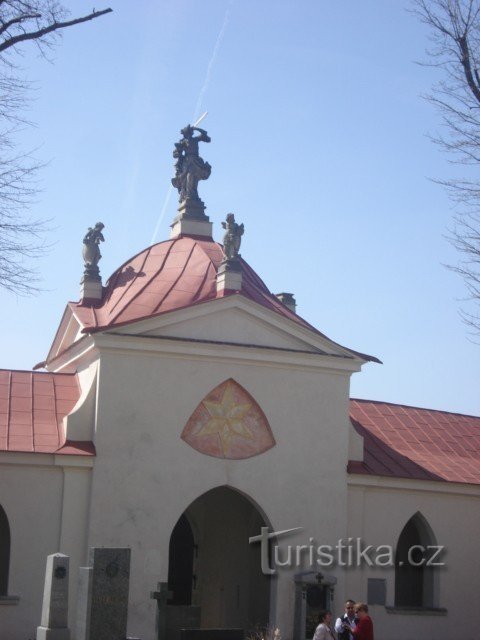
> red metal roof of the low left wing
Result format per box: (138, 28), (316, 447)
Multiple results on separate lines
(0, 370), (95, 455)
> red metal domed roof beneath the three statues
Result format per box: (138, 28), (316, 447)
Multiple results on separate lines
(69, 236), (312, 333)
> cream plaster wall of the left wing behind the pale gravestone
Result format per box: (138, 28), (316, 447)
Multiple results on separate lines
(0, 453), (90, 640)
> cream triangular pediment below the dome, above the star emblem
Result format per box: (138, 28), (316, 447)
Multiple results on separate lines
(110, 296), (355, 358)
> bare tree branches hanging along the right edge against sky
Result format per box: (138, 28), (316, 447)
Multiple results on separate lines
(413, 0), (480, 335)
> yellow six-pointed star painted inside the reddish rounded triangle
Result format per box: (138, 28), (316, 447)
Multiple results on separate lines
(197, 384), (254, 456)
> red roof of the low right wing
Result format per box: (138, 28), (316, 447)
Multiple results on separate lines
(348, 400), (480, 484)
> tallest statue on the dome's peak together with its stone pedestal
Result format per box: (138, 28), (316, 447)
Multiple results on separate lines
(171, 125), (212, 237)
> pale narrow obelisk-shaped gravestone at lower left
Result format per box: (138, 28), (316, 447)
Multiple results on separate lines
(37, 553), (70, 640)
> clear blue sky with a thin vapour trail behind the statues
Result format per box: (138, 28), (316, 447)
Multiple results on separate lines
(0, 0), (480, 414)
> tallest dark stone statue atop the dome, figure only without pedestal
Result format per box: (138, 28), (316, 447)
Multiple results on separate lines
(172, 124), (212, 202)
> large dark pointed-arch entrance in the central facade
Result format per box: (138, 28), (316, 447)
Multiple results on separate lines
(168, 487), (270, 638)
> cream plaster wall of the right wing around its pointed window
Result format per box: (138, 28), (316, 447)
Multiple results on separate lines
(344, 476), (480, 640)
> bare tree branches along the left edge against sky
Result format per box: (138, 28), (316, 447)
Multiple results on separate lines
(0, 0), (112, 294)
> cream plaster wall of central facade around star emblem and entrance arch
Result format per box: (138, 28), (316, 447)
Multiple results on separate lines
(88, 347), (349, 640)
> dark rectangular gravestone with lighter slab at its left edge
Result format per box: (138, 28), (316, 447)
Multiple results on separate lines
(76, 547), (130, 640)
